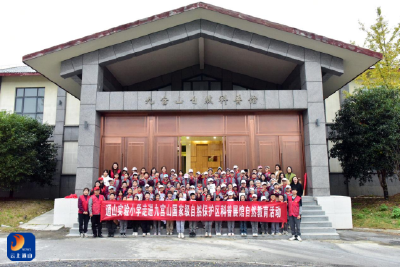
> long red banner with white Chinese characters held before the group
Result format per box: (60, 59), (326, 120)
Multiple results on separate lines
(101, 201), (287, 222)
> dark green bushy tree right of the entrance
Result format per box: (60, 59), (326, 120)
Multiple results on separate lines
(329, 86), (400, 199)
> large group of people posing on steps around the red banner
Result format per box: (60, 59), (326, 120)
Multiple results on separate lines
(78, 163), (303, 241)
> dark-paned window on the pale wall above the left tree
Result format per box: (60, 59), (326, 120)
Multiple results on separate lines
(15, 87), (44, 122)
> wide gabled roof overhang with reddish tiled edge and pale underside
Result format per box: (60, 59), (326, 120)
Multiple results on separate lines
(23, 2), (382, 98)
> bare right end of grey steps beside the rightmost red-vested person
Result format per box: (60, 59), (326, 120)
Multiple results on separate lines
(300, 196), (340, 240)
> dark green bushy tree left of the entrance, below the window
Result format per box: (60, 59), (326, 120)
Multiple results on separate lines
(0, 112), (57, 197)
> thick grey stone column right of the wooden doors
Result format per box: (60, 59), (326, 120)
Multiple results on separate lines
(300, 50), (330, 196)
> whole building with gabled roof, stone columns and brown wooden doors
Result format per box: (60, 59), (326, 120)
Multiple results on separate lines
(0, 3), (396, 198)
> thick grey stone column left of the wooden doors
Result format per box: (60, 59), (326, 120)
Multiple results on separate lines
(75, 51), (103, 194)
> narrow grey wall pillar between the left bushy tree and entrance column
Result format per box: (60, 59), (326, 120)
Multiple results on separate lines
(51, 88), (67, 198)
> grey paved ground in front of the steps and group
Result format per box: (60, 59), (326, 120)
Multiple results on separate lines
(0, 229), (400, 267)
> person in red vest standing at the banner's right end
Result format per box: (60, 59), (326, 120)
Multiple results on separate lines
(288, 188), (302, 242)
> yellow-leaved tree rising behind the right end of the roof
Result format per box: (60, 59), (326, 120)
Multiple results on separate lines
(356, 7), (400, 88)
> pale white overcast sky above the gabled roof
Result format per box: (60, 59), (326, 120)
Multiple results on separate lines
(0, 0), (400, 68)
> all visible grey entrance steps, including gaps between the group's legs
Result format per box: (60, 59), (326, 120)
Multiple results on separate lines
(68, 196), (339, 240)
